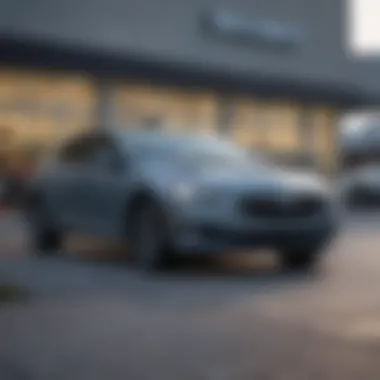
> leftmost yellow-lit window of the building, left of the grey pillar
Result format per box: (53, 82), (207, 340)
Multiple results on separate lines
(0, 69), (96, 165)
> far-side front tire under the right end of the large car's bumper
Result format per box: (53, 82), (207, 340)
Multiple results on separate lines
(280, 249), (320, 271)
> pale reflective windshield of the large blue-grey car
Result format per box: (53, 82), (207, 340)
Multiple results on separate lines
(124, 134), (263, 165)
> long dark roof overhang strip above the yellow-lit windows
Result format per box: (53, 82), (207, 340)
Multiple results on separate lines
(0, 34), (378, 109)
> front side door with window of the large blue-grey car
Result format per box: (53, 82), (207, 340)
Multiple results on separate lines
(76, 133), (130, 237)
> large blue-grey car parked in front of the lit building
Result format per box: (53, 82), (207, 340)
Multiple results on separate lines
(26, 131), (338, 269)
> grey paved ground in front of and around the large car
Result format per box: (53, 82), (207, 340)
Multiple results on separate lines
(0, 215), (380, 380)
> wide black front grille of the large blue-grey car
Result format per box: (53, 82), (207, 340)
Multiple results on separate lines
(240, 196), (324, 218)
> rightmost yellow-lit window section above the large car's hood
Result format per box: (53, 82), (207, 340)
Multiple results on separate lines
(235, 99), (337, 169)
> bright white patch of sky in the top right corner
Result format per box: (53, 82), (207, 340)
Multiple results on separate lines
(348, 0), (380, 57)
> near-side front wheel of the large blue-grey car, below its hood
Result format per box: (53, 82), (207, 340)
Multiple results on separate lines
(130, 200), (175, 272)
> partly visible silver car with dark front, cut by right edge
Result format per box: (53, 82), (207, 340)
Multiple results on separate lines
(340, 164), (380, 208)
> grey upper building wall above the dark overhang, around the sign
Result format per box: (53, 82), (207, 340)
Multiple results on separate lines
(0, 0), (352, 85)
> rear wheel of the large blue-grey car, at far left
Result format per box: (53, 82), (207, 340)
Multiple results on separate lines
(25, 197), (63, 257)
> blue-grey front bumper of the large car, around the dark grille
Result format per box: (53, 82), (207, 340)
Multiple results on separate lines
(165, 186), (340, 254)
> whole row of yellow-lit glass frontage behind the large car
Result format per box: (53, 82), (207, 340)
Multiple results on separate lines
(0, 69), (338, 170)
